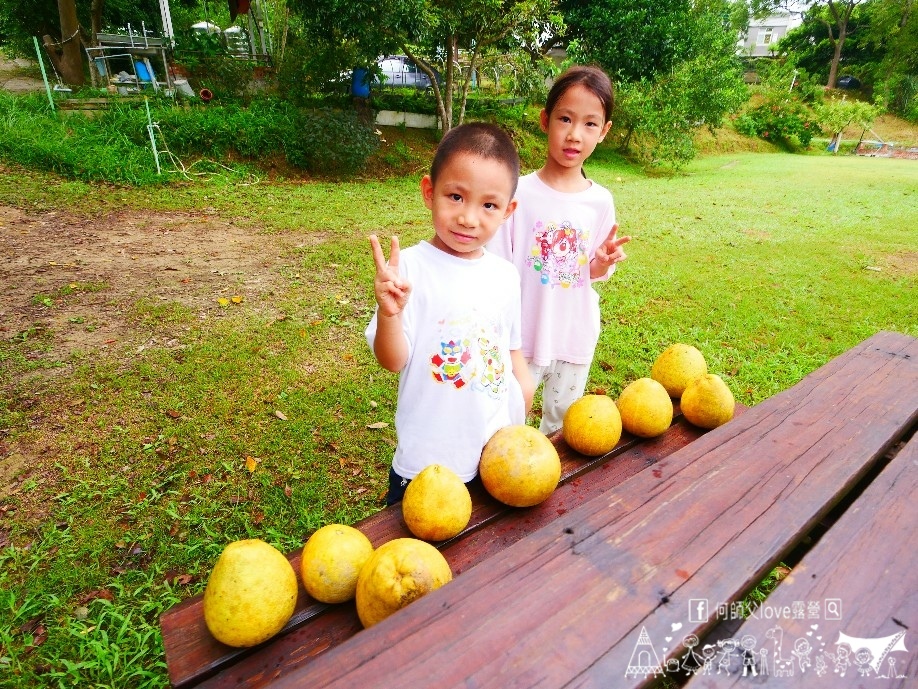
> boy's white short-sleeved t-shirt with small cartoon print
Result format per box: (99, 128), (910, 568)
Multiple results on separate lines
(366, 241), (525, 482)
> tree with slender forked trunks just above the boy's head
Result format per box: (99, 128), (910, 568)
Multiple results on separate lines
(290, 0), (560, 132)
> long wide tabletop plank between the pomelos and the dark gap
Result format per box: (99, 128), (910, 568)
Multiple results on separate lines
(260, 333), (918, 689)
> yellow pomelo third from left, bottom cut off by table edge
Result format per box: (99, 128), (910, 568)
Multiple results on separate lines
(356, 536), (453, 627)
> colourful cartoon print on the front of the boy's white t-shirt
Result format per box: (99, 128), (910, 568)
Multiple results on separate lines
(430, 318), (507, 399)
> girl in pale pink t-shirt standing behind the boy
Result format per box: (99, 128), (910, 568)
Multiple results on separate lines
(488, 67), (631, 434)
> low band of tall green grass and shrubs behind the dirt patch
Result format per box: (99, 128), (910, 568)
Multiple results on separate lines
(0, 92), (379, 185)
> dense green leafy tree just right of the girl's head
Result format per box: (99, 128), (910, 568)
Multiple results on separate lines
(561, 0), (747, 165)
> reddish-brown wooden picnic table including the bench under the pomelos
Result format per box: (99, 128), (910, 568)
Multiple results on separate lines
(162, 333), (918, 688)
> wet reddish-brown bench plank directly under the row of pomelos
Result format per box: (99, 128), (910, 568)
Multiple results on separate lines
(160, 403), (698, 688)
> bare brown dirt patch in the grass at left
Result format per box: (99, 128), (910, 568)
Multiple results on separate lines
(0, 205), (289, 370)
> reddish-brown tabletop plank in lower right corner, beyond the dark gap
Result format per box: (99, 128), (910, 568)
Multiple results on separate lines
(683, 436), (918, 689)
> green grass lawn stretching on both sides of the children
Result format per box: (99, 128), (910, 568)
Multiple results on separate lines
(0, 149), (918, 687)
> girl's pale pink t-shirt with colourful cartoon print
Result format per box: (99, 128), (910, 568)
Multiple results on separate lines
(488, 172), (615, 366)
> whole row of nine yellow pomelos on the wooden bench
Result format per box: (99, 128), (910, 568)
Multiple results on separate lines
(204, 344), (734, 646)
